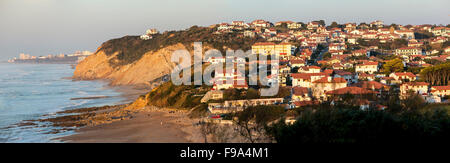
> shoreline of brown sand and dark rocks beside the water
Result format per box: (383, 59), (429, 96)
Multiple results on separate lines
(11, 68), (203, 143)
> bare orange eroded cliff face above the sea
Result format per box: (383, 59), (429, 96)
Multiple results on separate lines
(73, 44), (188, 87)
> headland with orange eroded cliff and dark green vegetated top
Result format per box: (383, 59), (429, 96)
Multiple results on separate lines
(73, 26), (264, 87)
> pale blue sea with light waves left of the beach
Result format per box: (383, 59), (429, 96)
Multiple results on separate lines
(0, 63), (126, 143)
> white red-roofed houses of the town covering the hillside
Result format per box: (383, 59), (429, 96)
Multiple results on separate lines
(162, 20), (450, 114)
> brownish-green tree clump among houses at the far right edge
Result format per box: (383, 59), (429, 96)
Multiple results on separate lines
(420, 62), (450, 85)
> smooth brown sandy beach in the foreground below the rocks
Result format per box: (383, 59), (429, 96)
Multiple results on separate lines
(61, 108), (202, 143)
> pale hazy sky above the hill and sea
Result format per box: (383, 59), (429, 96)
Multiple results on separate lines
(0, 0), (450, 60)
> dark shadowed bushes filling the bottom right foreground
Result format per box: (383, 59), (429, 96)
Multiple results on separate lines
(268, 105), (450, 144)
